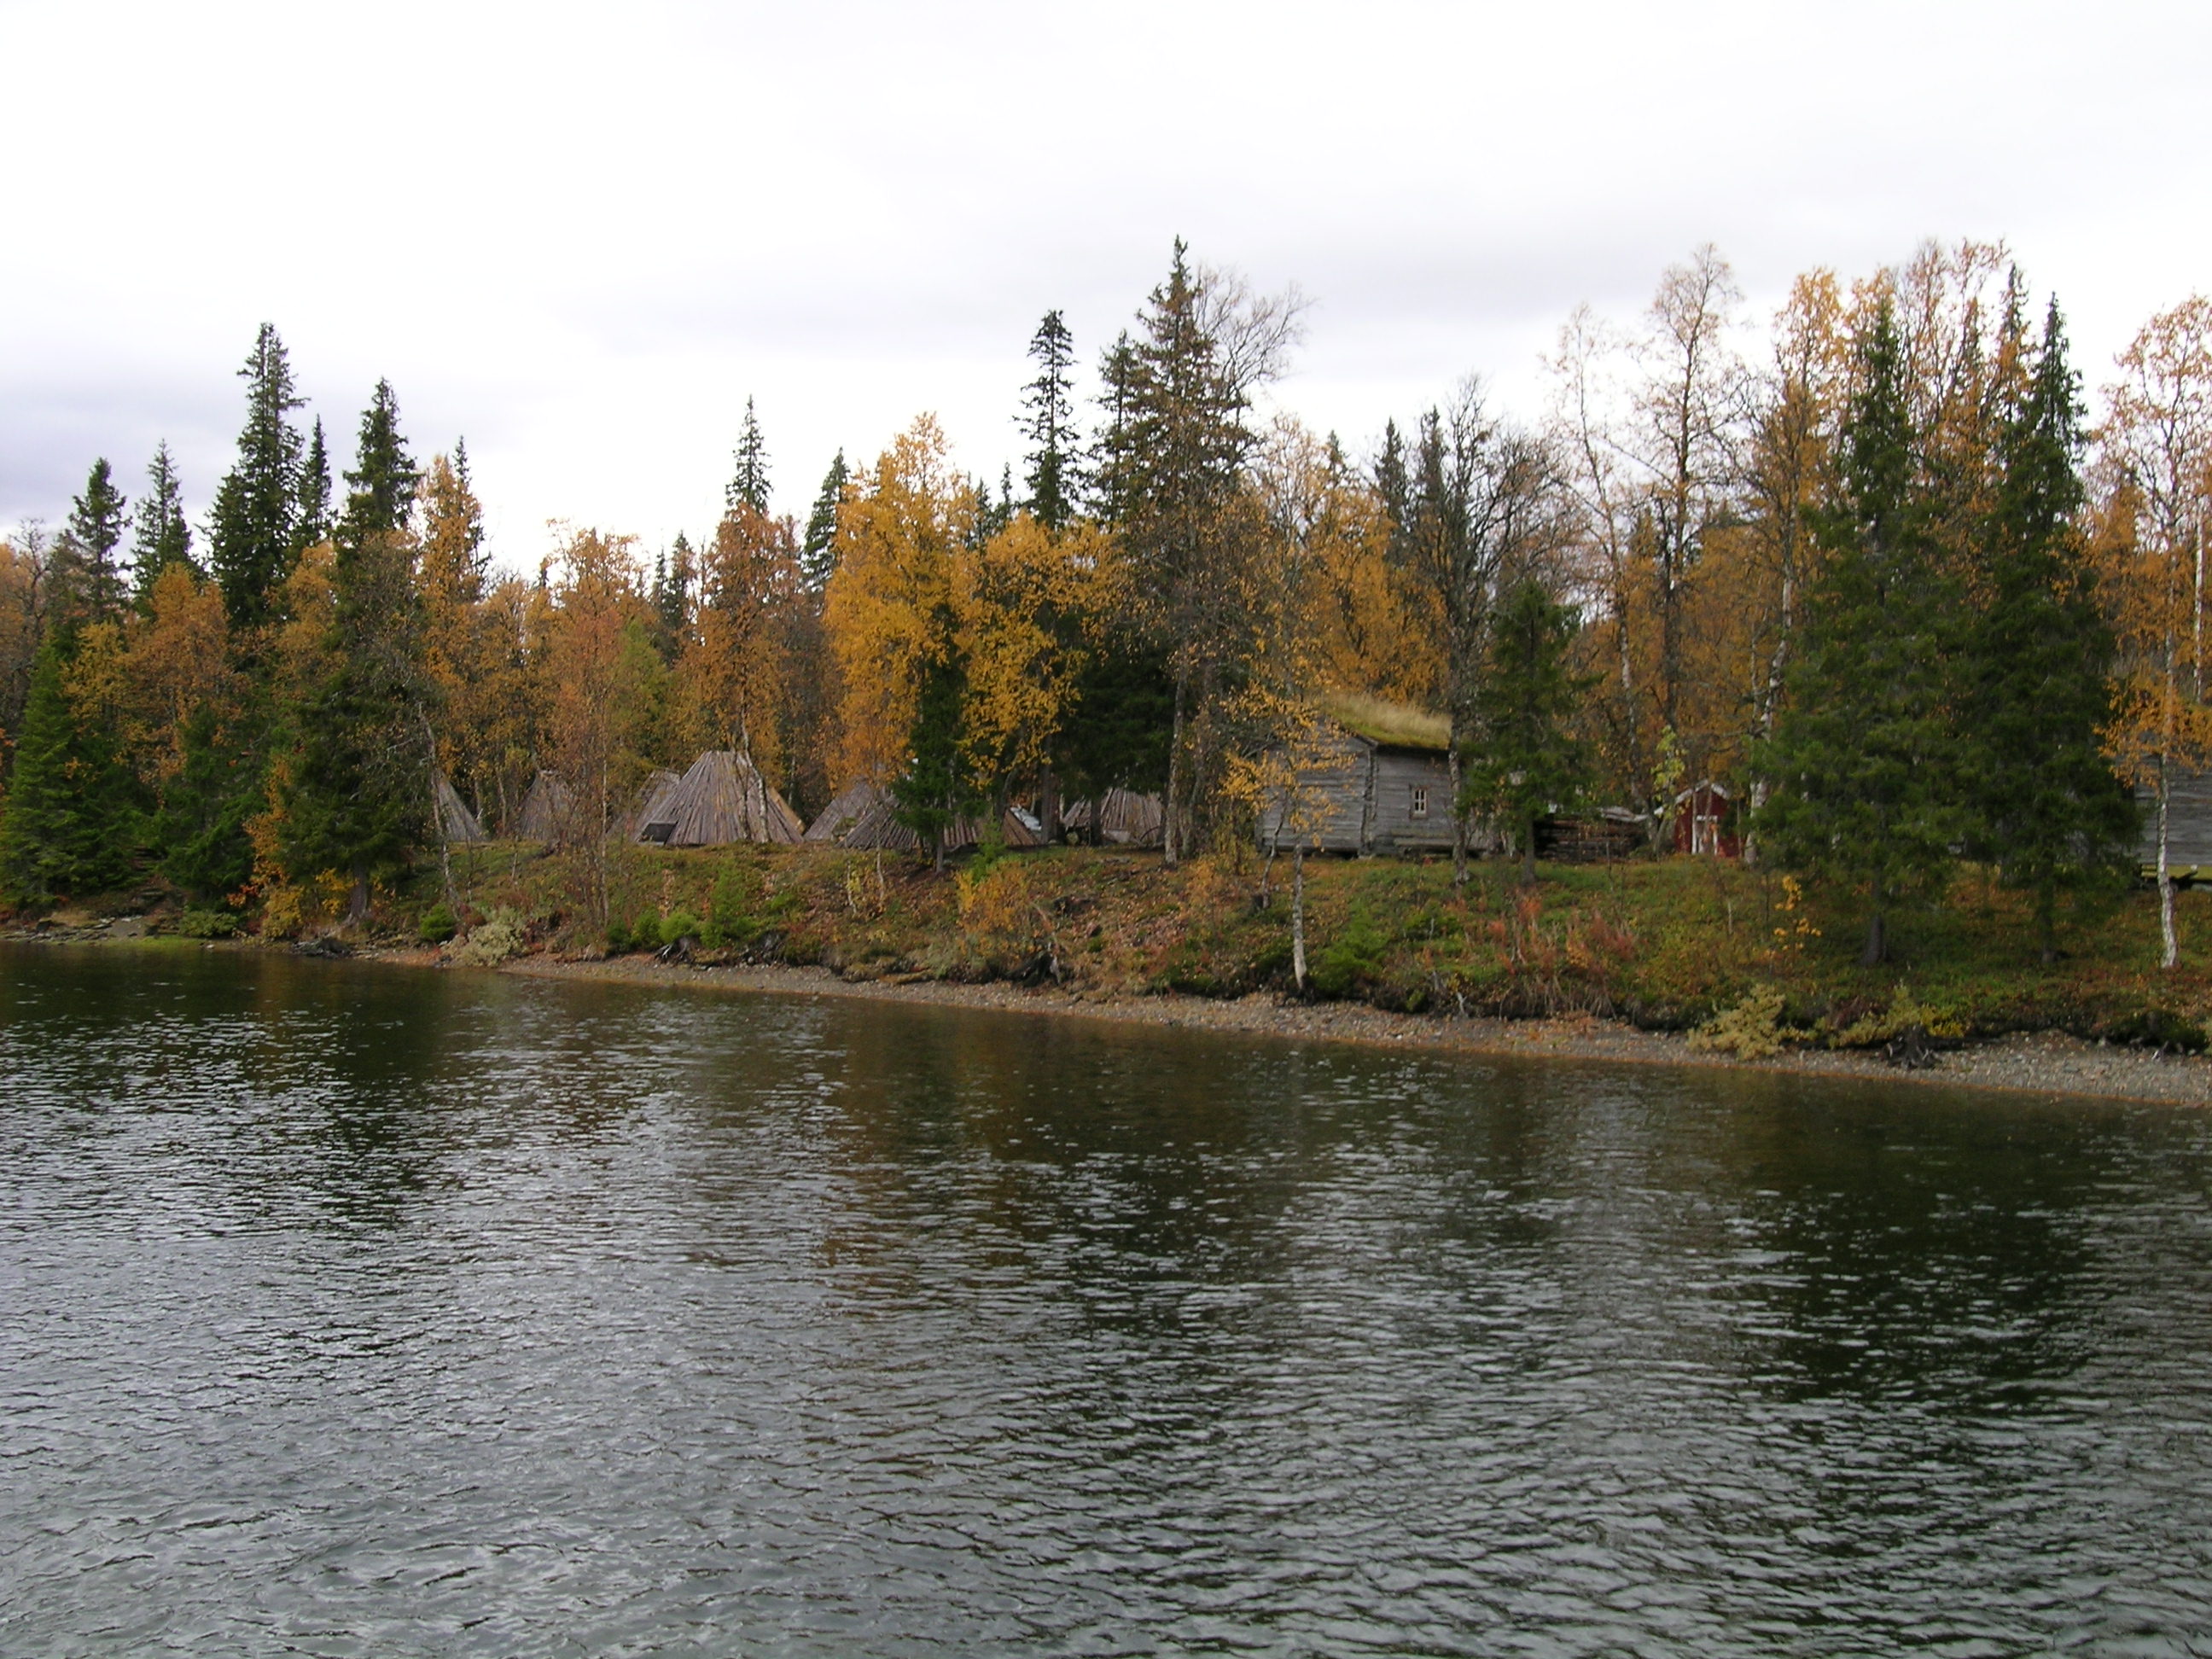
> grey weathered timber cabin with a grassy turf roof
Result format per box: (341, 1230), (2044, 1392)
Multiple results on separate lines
(1259, 696), (1451, 854)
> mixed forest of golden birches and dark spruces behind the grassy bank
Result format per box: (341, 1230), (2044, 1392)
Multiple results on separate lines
(0, 243), (2212, 981)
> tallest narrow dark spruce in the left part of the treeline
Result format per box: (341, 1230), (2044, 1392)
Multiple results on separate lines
(208, 323), (301, 628)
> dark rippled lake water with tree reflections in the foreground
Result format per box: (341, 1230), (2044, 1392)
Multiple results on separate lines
(0, 946), (2212, 1656)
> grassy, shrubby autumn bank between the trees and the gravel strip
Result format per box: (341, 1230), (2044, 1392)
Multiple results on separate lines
(224, 845), (2212, 1049)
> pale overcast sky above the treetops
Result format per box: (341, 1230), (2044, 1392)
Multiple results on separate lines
(0, 0), (2212, 567)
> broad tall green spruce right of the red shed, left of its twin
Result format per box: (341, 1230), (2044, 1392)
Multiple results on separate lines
(1759, 306), (1966, 967)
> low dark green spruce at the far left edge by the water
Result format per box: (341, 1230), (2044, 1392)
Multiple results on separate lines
(0, 628), (142, 903)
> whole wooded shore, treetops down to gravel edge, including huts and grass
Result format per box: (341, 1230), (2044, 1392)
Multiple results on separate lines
(0, 242), (2212, 1106)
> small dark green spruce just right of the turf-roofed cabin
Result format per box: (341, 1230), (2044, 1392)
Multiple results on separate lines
(1460, 582), (1591, 881)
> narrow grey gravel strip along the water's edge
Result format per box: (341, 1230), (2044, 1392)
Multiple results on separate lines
(498, 953), (2212, 1106)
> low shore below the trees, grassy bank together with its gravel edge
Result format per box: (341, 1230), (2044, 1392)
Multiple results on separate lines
(13, 843), (2212, 1106)
